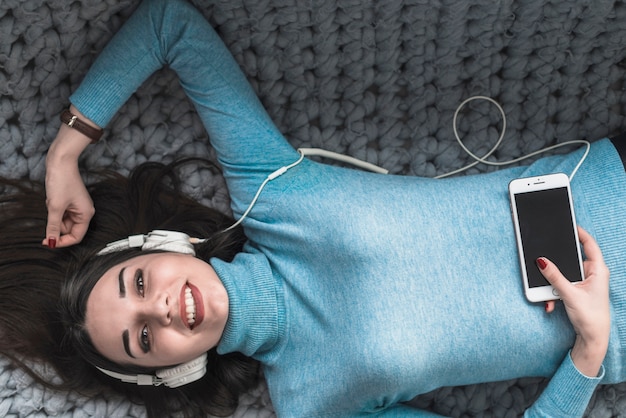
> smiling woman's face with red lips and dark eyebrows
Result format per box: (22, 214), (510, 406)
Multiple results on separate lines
(85, 253), (228, 367)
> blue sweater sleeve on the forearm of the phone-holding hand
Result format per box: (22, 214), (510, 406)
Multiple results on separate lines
(524, 353), (604, 418)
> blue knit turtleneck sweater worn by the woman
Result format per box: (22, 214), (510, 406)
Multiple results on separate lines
(71, 0), (626, 417)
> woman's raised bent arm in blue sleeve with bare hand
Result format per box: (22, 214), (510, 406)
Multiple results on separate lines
(44, 0), (296, 246)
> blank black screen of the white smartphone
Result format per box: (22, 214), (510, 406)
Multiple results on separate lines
(515, 187), (583, 288)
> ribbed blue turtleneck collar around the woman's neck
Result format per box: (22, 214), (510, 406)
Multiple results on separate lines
(211, 248), (285, 359)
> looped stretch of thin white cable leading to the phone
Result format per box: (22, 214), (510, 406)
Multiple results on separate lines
(435, 96), (591, 181)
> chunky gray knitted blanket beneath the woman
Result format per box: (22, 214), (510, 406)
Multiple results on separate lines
(0, 0), (626, 418)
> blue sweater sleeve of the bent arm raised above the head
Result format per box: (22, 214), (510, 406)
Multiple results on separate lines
(70, 0), (295, 169)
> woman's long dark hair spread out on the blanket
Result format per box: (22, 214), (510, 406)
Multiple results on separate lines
(0, 161), (259, 416)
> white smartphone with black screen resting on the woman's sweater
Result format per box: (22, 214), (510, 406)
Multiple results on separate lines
(509, 173), (584, 302)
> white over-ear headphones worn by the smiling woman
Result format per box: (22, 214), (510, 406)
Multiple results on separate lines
(96, 230), (208, 388)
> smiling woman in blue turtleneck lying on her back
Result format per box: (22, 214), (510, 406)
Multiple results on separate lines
(28, 1), (626, 416)
